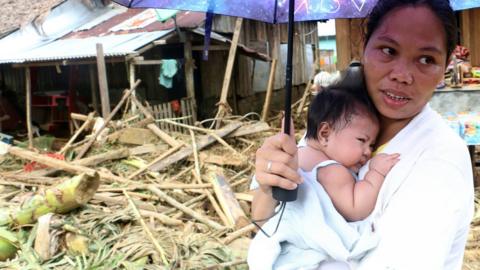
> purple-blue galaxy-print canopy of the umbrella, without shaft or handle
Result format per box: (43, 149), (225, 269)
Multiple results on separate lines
(111, 0), (480, 23)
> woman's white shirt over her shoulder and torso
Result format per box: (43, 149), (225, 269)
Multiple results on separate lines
(352, 105), (474, 270)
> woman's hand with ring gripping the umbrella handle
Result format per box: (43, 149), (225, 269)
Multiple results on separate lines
(255, 133), (302, 195)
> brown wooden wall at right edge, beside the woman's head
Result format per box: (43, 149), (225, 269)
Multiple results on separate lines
(460, 8), (480, 66)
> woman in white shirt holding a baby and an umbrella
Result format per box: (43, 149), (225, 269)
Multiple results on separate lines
(252, 0), (474, 270)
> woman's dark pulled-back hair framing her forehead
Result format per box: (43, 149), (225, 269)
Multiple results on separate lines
(365, 0), (457, 64)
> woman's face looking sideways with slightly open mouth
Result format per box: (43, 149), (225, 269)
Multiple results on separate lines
(363, 6), (447, 120)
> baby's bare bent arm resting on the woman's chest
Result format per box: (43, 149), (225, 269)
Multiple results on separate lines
(317, 154), (399, 221)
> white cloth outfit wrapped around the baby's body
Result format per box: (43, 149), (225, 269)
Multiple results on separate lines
(248, 160), (378, 270)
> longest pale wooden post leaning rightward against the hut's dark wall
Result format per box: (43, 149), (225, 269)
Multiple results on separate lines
(215, 18), (243, 128)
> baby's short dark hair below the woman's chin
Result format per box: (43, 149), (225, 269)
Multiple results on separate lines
(306, 63), (378, 139)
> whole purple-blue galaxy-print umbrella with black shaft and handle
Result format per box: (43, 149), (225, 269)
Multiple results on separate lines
(114, 0), (480, 201)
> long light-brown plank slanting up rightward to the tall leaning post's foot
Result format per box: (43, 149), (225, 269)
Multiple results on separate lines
(150, 122), (242, 171)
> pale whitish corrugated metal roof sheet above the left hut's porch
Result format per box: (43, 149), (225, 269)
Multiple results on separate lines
(0, 29), (173, 64)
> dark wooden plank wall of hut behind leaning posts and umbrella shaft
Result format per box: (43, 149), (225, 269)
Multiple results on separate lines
(197, 16), (318, 117)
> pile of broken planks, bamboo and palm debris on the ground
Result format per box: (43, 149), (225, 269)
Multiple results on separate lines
(0, 84), (277, 269)
